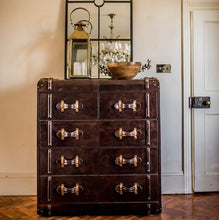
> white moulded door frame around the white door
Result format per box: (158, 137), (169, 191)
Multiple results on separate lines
(182, 0), (219, 193)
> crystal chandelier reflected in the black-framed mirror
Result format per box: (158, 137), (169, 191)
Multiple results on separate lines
(92, 14), (131, 69)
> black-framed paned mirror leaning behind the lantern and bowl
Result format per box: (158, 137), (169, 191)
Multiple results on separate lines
(65, 0), (133, 79)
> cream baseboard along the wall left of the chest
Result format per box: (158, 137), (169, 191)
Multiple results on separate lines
(0, 172), (37, 196)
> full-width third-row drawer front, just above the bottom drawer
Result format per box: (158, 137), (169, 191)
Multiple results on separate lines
(40, 147), (158, 175)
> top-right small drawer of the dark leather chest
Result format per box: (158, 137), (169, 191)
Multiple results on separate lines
(100, 92), (158, 119)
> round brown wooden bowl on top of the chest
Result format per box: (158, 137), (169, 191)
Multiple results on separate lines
(107, 62), (141, 79)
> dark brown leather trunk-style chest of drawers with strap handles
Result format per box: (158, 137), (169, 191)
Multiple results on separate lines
(37, 78), (161, 215)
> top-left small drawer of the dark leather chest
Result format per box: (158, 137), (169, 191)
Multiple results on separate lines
(39, 93), (97, 120)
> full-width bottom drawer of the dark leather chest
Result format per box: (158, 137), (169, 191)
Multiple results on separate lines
(38, 175), (160, 204)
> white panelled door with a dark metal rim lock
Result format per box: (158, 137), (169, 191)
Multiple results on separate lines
(193, 10), (219, 192)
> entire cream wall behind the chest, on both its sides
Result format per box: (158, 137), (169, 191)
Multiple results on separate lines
(0, 0), (184, 195)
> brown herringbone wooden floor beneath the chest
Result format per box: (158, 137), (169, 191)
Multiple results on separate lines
(0, 193), (219, 220)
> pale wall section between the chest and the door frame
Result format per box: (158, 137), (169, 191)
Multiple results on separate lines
(133, 0), (184, 193)
